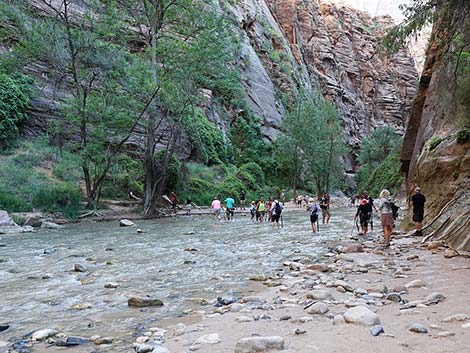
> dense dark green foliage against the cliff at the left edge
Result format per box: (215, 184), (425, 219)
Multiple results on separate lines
(0, 73), (32, 143)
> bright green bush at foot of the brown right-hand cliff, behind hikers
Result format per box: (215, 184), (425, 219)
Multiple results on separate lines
(357, 148), (403, 195)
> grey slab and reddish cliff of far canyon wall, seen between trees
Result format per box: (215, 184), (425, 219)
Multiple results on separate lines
(5, 0), (417, 164)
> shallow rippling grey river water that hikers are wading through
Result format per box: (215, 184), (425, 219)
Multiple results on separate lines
(0, 208), (354, 346)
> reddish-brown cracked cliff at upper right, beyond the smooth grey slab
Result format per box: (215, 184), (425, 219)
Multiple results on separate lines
(269, 0), (418, 162)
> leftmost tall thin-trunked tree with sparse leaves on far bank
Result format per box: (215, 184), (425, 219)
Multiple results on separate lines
(2, 0), (148, 207)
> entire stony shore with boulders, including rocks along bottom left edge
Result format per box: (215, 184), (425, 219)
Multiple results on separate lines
(0, 220), (470, 353)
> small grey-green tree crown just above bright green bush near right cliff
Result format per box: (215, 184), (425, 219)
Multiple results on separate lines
(359, 125), (401, 171)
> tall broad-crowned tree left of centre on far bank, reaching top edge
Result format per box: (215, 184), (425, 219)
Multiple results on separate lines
(117, 0), (234, 216)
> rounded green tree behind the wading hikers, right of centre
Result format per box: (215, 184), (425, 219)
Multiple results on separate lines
(278, 92), (346, 194)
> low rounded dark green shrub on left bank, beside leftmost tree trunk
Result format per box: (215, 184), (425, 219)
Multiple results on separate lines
(32, 183), (82, 218)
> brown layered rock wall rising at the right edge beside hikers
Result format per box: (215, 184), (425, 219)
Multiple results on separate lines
(401, 9), (470, 252)
